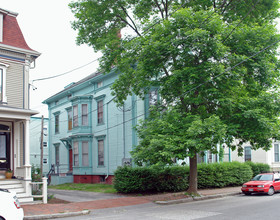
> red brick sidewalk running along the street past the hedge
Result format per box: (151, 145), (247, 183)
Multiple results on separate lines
(22, 187), (241, 219)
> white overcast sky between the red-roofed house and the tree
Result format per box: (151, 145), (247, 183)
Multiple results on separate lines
(0, 0), (100, 117)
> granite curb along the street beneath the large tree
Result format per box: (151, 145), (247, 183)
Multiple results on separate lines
(154, 192), (241, 205)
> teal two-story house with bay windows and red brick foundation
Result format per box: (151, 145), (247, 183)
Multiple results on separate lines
(43, 69), (157, 185)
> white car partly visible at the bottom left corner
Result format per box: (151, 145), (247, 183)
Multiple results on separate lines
(0, 189), (24, 220)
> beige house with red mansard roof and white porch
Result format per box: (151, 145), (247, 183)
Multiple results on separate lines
(0, 8), (40, 201)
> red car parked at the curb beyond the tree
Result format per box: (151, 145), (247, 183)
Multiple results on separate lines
(241, 173), (280, 196)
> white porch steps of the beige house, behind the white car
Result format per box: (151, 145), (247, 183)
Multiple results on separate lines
(0, 179), (33, 204)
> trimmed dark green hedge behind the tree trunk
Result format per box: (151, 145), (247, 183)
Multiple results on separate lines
(114, 162), (254, 193)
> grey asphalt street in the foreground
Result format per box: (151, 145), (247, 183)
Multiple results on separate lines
(52, 193), (280, 220)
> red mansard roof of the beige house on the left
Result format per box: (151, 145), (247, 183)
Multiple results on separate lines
(0, 8), (40, 56)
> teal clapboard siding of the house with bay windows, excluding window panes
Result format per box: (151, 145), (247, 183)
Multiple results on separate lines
(43, 71), (147, 179)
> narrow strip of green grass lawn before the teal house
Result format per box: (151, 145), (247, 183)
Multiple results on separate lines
(48, 183), (117, 193)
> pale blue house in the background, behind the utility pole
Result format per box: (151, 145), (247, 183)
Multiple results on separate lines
(29, 117), (49, 176)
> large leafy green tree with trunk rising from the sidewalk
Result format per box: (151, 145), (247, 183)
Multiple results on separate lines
(70, 0), (280, 192)
